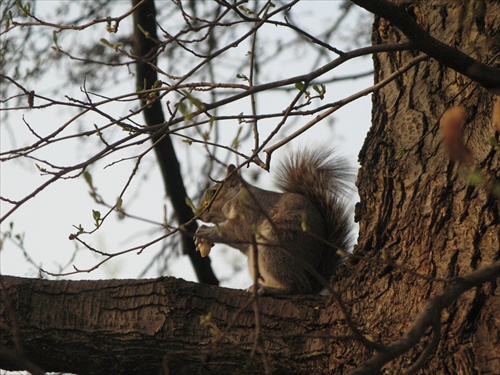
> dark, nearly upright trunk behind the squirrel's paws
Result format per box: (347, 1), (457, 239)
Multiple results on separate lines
(132, 0), (219, 285)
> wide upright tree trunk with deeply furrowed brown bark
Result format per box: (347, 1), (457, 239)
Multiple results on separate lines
(339, 1), (500, 374)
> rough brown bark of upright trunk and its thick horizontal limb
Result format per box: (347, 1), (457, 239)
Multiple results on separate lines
(0, 1), (500, 374)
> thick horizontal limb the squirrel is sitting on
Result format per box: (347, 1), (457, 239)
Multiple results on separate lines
(0, 276), (356, 374)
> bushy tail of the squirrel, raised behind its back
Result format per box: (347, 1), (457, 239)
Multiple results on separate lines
(277, 149), (355, 284)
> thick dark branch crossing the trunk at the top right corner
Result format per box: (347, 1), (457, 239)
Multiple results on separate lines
(351, 0), (500, 94)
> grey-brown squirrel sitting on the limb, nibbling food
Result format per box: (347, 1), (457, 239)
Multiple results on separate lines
(194, 149), (354, 295)
